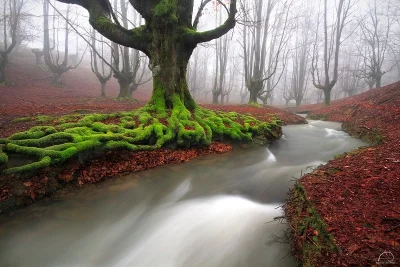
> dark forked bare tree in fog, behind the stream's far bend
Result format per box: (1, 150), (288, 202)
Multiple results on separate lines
(311, 0), (353, 105)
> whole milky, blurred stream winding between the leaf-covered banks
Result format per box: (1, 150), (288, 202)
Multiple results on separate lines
(0, 121), (365, 267)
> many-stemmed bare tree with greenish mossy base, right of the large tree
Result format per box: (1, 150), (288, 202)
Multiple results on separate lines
(241, 0), (292, 103)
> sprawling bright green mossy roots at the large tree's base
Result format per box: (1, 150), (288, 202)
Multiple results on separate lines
(0, 103), (282, 176)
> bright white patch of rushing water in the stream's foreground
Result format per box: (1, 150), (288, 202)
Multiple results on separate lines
(113, 196), (281, 267)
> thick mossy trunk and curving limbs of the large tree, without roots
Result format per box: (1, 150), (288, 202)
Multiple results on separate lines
(59, 0), (237, 109)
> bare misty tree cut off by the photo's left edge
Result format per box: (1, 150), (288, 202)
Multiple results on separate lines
(0, 0), (27, 83)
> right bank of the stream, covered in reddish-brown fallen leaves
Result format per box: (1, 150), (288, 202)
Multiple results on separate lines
(285, 83), (400, 266)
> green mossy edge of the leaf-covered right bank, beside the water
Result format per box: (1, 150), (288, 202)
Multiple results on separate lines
(285, 182), (339, 267)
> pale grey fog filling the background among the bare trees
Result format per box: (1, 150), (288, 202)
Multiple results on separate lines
(0, 0), (400, 105)
